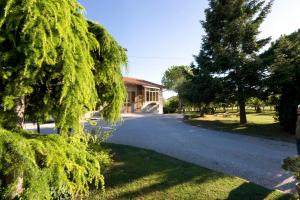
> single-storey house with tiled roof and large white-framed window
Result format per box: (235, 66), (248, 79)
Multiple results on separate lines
(122, 77), (163, 114)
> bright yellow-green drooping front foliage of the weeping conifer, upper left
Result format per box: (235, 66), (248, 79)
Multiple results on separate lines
(0, 0), (97, 133)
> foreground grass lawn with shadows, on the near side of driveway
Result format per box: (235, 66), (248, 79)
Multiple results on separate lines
(89, 145), (291, 200)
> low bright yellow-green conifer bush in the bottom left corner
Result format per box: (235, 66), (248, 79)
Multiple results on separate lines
(0, 128), (111, 199)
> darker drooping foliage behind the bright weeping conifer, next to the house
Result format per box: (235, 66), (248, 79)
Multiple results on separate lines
(89, 22), (127, 122)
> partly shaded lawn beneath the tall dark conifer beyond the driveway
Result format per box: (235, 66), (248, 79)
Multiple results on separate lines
(186, 112), (295, 142)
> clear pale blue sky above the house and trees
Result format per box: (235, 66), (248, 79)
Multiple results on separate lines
(79, 0), (300, 97)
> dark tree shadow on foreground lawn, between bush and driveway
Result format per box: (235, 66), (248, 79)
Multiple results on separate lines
(101, 144), (226, 199)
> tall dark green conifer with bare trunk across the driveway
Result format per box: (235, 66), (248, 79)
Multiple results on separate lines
(196, 0), (273, 124)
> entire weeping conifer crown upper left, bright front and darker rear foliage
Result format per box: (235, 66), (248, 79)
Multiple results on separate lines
(0, 0), (126, 135)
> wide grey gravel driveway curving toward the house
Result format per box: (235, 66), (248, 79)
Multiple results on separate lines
(108, 115), (296, 192)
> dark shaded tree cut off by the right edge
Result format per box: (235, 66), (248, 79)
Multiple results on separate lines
(262, 30), (300, 133)
